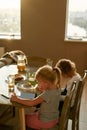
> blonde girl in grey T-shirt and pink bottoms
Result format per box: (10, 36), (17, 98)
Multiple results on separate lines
(10, 65), (61, 130)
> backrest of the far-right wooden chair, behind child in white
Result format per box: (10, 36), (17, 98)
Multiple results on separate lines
(69, 71), (87, 119)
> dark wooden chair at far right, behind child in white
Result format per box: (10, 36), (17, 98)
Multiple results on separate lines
(69, 70), (87, 130)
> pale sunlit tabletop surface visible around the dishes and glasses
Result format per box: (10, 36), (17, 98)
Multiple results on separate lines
(0, 65), (37, 99)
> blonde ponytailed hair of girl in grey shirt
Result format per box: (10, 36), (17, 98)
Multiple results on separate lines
(35, 65), (61, 86)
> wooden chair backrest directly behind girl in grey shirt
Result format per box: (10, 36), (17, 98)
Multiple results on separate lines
(58, 82), (76, 130)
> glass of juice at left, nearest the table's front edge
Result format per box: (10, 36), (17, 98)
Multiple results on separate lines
(8, 75), (15, 92)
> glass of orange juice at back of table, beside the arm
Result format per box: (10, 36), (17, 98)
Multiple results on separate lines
(17, 55), (26, 71)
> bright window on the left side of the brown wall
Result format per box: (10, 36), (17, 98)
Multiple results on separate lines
(0, 0), (21, 39)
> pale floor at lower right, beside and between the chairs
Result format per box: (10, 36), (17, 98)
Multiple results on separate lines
(68, 81), (87, 130)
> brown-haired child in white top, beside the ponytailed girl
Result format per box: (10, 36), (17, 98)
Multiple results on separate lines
(56, 59), (81, 115)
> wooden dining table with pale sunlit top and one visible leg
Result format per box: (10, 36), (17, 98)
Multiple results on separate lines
(0, 64), (36, 130)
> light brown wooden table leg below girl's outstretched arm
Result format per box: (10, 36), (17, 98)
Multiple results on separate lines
(19, 108), (26, 130)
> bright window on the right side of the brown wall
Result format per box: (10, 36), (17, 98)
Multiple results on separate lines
(65, 0), (87, 41)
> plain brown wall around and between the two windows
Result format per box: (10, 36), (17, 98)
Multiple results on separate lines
(0, 0), (87, 73)
